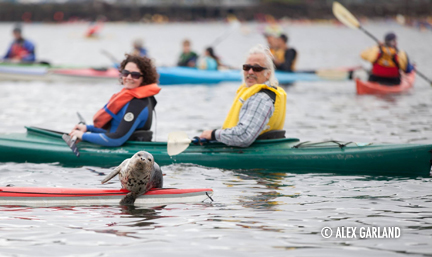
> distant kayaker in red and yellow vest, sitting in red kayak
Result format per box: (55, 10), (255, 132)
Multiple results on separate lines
(360, 33), (414, 85)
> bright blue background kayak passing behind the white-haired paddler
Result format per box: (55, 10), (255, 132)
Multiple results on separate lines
(157, 67), (323, 85)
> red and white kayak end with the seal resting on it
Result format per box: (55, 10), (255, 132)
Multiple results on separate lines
(0, 187), (213, 206)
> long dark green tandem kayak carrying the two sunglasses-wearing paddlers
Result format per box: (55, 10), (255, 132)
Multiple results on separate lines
(0, 127), (432, 176)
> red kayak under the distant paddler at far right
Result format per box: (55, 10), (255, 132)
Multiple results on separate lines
(356, 72), (415, 95)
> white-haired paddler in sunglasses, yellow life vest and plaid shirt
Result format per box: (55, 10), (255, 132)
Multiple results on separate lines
(200, 45), (286, 147)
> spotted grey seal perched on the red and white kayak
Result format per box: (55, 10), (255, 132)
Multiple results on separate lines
(102, 151), (163, 205)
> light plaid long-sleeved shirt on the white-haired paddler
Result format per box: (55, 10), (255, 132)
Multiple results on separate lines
(214, 92), (274, 147)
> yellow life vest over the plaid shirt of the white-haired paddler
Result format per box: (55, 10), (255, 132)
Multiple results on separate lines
(222, 84), (286, 135)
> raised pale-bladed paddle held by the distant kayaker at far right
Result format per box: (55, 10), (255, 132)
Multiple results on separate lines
(333, 2), (432, 86)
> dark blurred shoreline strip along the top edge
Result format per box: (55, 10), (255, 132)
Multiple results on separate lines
(0, 0), (432, 23)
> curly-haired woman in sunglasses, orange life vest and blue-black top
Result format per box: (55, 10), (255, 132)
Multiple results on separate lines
(70, 55), (161, 146)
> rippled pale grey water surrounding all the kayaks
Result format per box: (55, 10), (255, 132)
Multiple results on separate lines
(0, 23), (432, 256)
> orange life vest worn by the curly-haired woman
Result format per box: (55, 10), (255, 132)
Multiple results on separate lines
(93, 84), (161, 128)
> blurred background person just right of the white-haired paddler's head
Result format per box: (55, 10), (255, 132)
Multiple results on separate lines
(273, 34), (297, 72)
